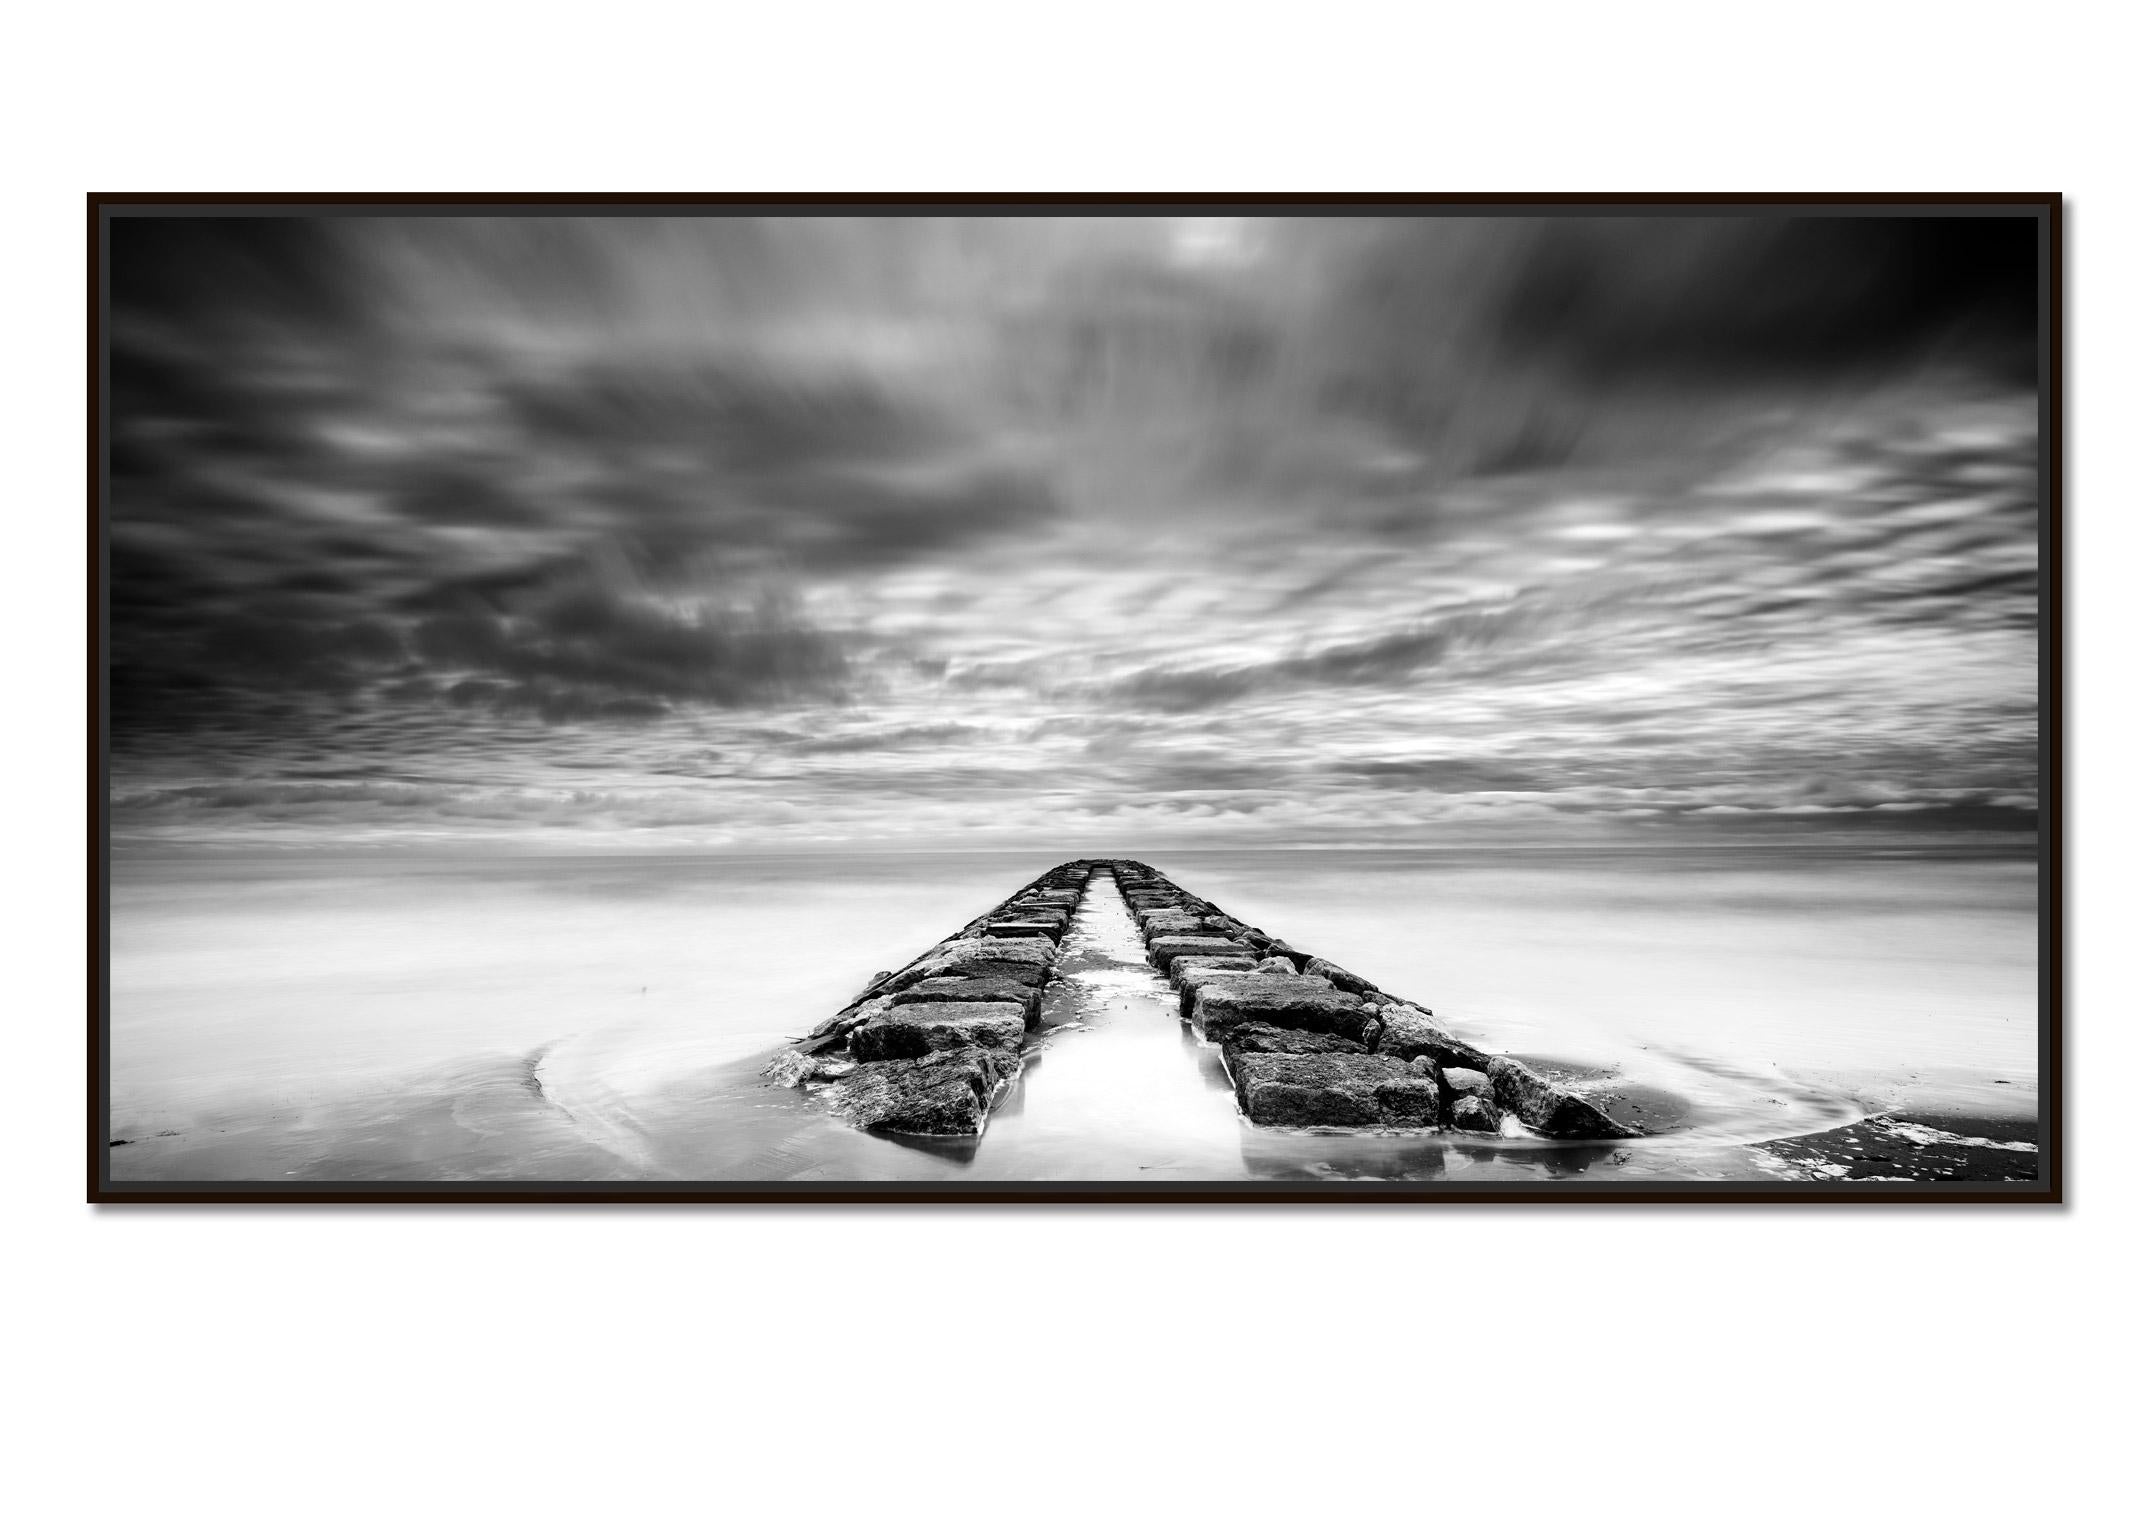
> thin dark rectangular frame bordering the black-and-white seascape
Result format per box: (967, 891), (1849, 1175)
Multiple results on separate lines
(86, 193), (2065, 1205)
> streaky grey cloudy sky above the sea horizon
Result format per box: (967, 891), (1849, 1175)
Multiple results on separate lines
(107, 215), (2039, 848)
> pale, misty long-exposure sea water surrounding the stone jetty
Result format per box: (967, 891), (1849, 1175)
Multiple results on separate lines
(110, 846), (2037, 1181)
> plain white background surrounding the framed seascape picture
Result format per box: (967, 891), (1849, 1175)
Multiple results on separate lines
(12, 0), (2149, 1536)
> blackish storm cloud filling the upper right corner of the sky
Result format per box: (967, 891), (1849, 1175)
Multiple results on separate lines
(1315, 217), (2037, 475)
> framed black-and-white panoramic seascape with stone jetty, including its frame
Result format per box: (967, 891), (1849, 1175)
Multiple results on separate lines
(88, 193), (2061, 1203)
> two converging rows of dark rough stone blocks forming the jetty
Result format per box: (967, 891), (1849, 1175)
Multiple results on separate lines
(767, 859), (1640, 1141)
